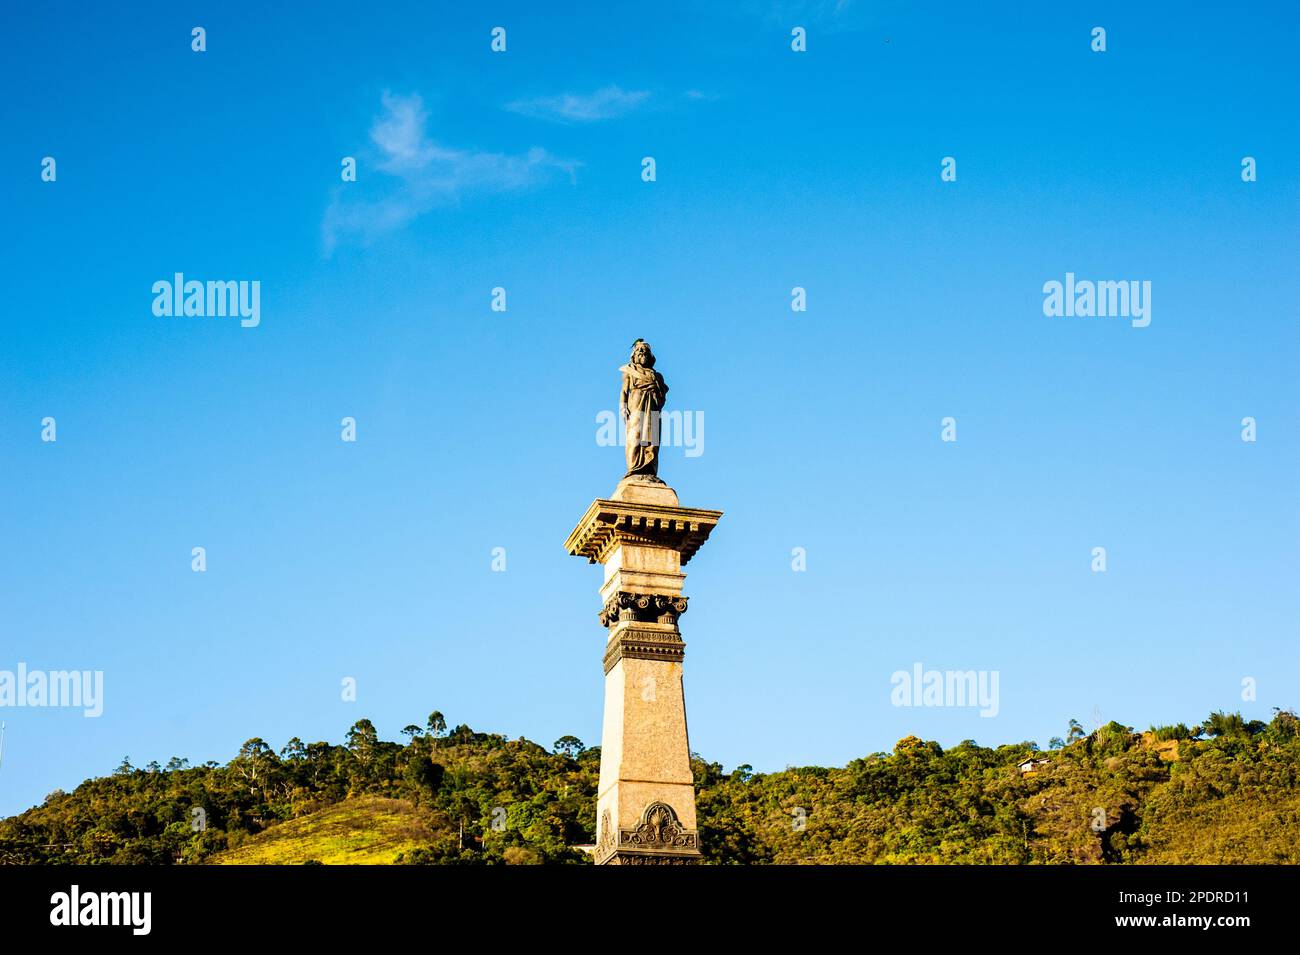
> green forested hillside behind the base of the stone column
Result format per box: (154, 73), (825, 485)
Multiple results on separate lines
(0, 711), (1300, 865)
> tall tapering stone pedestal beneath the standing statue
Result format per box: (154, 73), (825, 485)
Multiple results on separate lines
(564, 478), (722, 865)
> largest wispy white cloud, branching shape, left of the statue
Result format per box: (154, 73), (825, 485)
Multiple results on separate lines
(321, 92), (579, 255)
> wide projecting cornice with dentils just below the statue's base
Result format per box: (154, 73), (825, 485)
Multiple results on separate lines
(564, 498), (723, 564)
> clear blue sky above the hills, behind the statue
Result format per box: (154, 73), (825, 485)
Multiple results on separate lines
(0, 3), (1300, 813)
